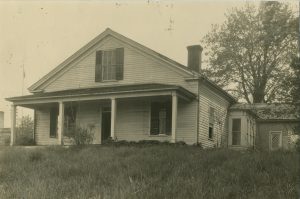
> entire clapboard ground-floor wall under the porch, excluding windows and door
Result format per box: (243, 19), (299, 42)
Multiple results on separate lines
(35, 97), (197, 145)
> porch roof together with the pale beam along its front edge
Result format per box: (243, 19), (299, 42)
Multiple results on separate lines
(6, 84), (196, 105)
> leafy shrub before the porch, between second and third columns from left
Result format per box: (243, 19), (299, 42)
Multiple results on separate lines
(69, 127), (94, 145)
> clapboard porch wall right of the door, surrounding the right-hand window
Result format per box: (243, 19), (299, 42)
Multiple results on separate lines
(116, 99), (197, 144)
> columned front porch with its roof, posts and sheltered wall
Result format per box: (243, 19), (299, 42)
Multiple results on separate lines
(9, 84), (196, 145)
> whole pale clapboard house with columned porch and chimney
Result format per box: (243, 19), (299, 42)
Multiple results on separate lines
(7, 28), (298, 148)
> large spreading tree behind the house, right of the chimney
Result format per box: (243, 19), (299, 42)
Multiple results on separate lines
(203, 2), (297, 103)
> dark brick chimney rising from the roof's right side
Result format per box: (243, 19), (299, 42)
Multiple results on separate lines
(187, 45), (203, 72)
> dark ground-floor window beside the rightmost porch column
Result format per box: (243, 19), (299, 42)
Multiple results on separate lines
(150, 102), (172, 135)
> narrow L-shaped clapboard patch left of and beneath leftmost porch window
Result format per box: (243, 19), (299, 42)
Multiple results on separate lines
(35, 107), (58, 145)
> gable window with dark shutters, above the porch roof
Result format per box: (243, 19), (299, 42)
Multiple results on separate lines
(95, 48), (124, 82)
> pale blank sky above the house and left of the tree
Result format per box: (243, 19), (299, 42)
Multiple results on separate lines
(0, 0), (298, 127)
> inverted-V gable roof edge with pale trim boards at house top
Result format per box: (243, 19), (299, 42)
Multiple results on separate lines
(28, 28), (199, 92)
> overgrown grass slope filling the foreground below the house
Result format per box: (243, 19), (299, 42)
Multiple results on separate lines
(0, 145), (299, 199)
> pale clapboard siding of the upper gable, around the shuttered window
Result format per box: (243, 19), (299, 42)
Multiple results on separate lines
(41, 36), (197, 92)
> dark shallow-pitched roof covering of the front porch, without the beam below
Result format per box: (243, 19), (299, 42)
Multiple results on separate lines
(6, 83), (196, 103)
